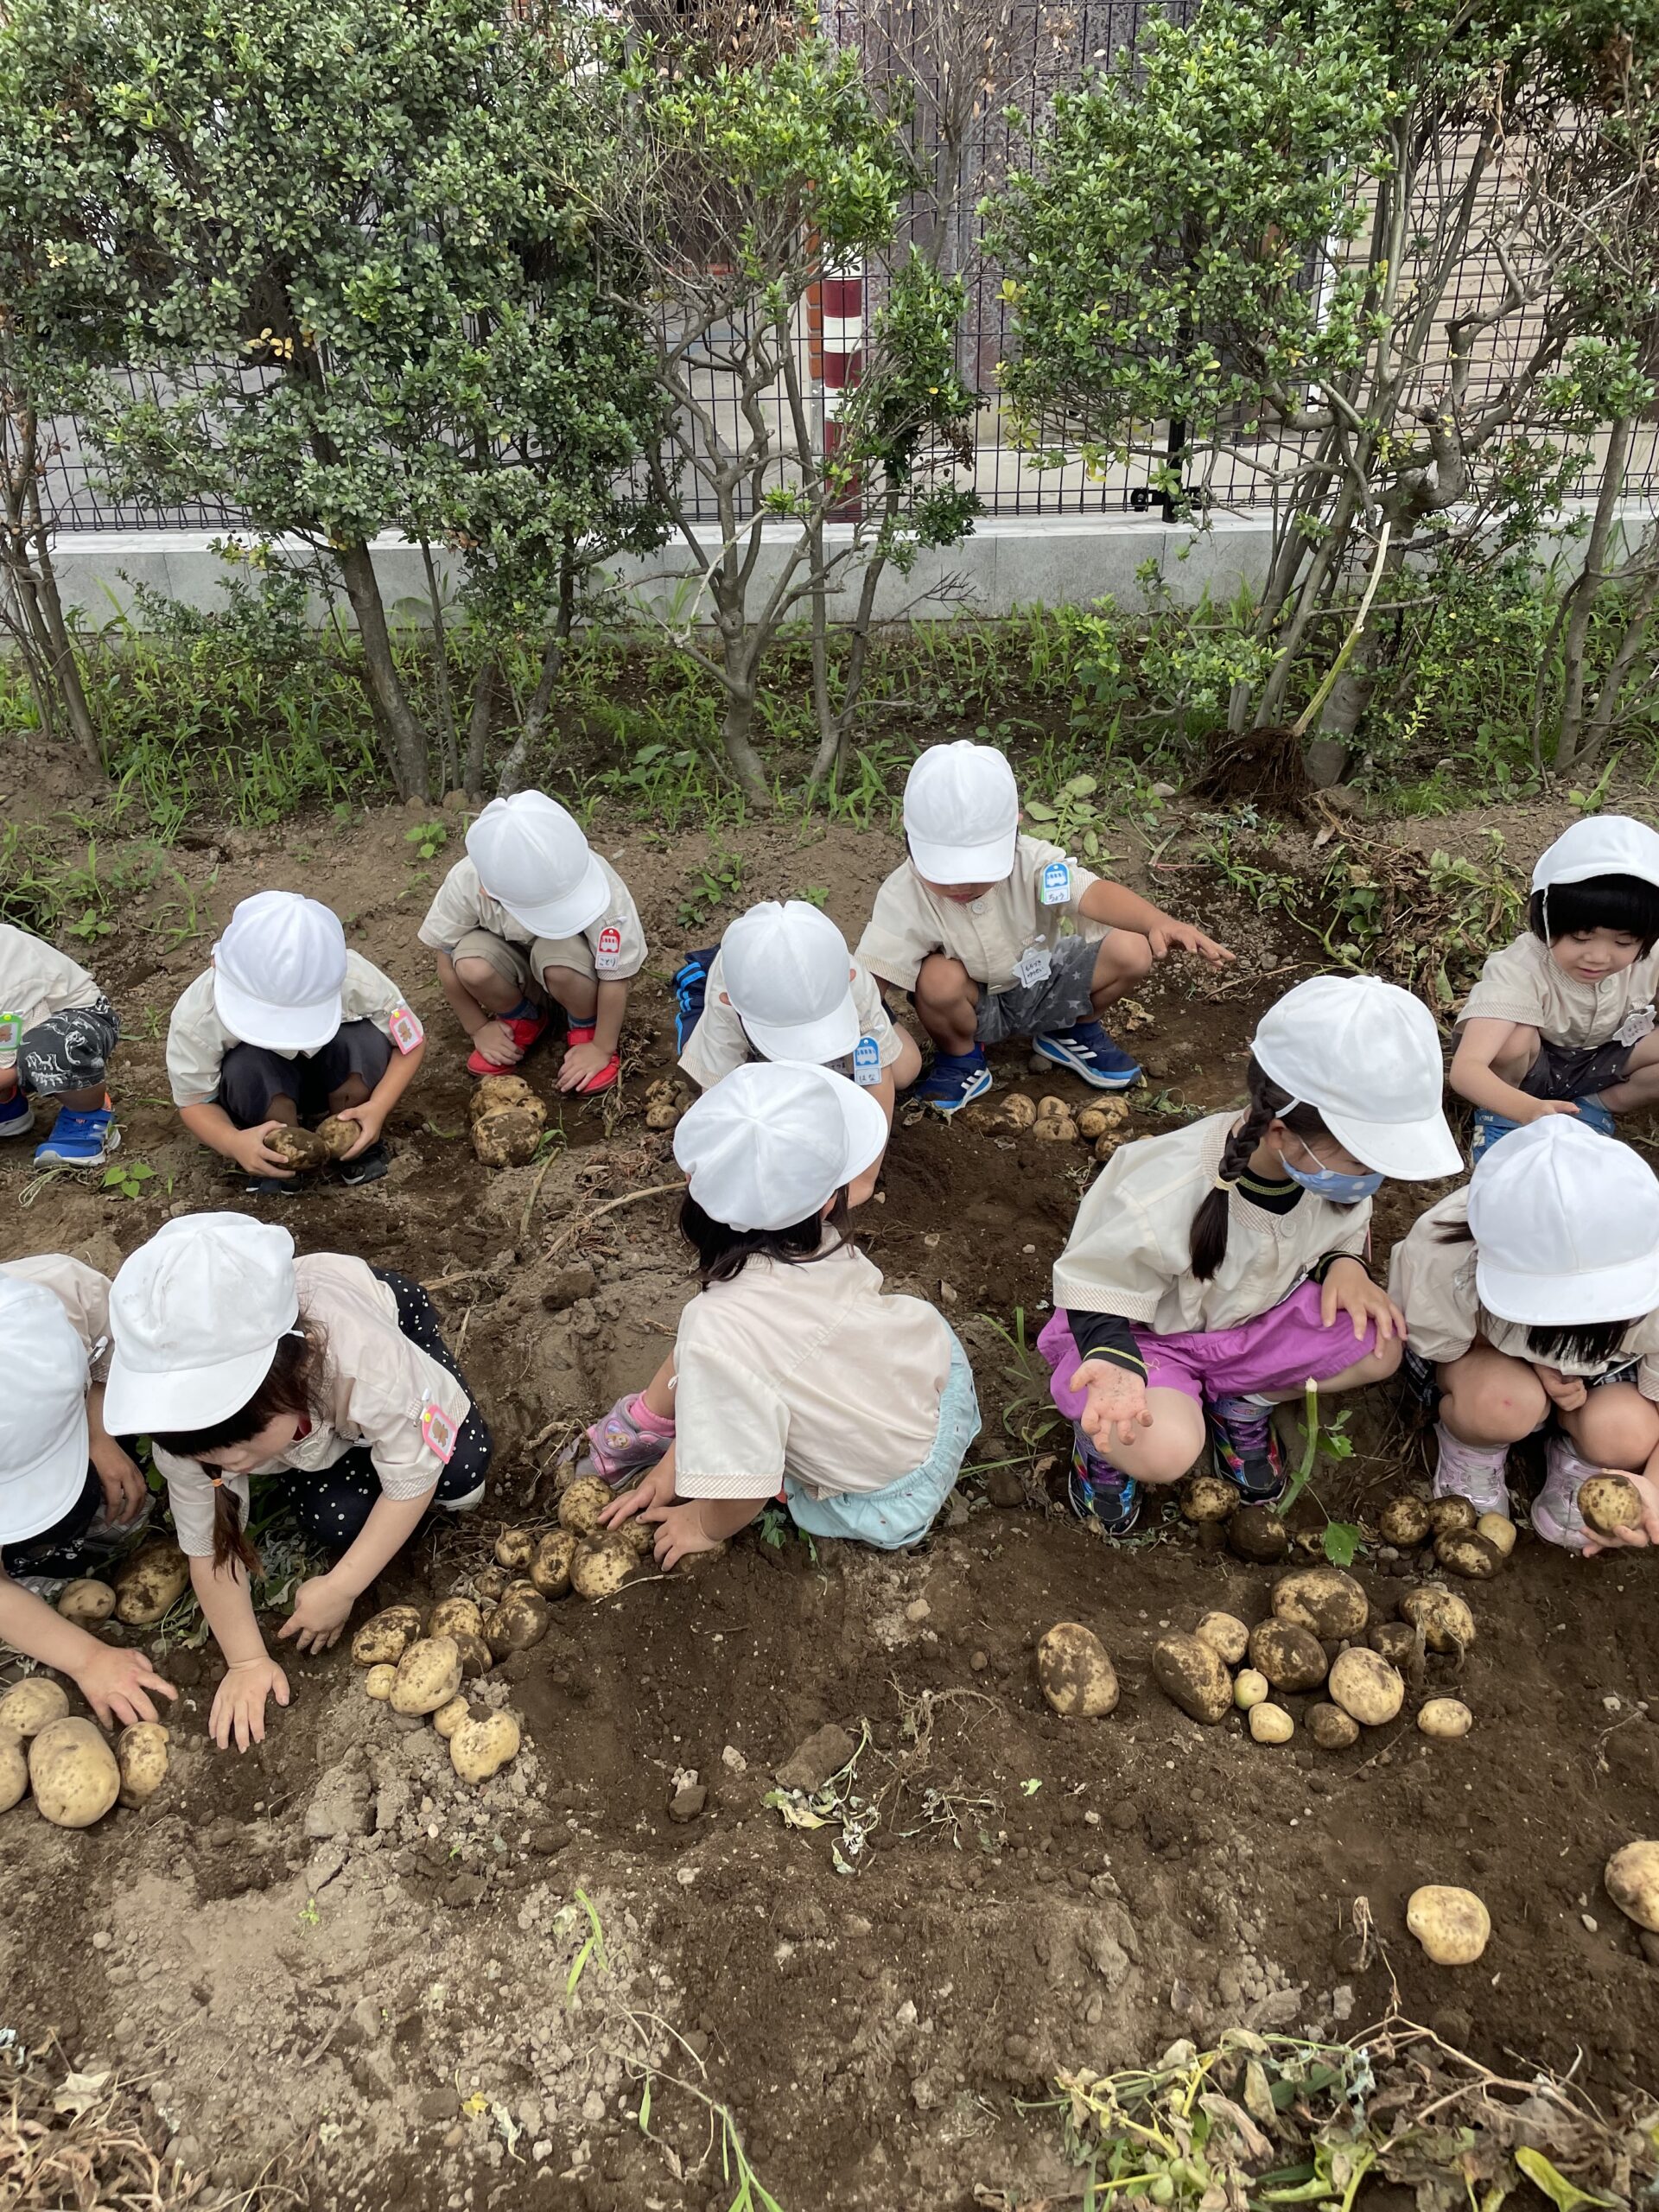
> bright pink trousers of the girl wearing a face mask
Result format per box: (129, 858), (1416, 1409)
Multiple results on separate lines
(1038, 1283), (1376, 1421)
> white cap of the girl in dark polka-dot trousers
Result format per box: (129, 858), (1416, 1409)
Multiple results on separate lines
(104, 1214), (299, 1435)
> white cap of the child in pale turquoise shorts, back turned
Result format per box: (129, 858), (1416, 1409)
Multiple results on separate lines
(675, 1059), (887, 1230)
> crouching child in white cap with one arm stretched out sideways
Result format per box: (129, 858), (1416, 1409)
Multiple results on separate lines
(858, 739), (1232, 1115)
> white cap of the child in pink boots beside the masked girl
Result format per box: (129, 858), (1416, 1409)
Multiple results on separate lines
(1469, 1113), (1659, 1327)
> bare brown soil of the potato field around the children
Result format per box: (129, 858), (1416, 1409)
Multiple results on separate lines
(0, 769), (1659, 2212)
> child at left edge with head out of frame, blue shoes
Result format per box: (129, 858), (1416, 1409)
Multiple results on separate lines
(0, 923), (122, 1168)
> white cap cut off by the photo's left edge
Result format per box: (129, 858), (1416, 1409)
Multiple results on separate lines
(0, 1274), (92, 1544)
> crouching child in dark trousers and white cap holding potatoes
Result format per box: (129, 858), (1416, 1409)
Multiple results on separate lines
(168, 892), (427, 1194)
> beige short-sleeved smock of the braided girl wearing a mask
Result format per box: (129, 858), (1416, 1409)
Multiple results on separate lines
(1055, 1113), (1371, 1336)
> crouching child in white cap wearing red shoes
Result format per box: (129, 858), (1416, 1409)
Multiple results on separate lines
(420, 791), (646, 1095)
